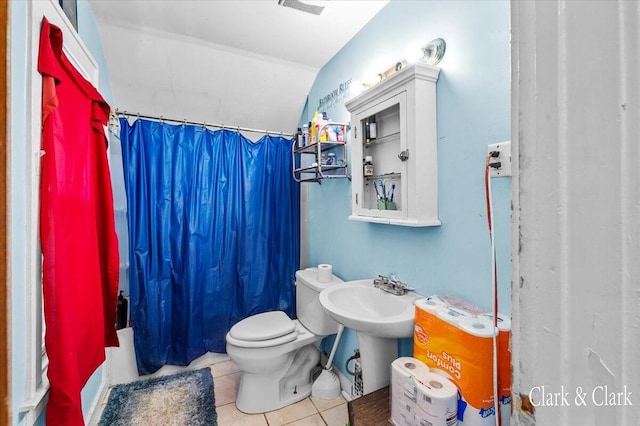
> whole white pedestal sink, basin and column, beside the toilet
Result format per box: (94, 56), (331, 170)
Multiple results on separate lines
(320, 279), (423, 395)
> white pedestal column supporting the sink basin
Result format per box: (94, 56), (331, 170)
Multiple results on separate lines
(356, 332), (398, 395)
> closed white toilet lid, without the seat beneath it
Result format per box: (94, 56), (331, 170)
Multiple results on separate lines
(229, 311), (296, 341)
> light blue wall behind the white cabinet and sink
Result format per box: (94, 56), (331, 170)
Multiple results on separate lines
(308, 0), (511, 378)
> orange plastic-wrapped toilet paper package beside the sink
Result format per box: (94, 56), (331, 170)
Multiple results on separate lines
(413, 296), (511, 426)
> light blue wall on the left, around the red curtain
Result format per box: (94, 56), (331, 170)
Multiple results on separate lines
(9, 0), (121, 424)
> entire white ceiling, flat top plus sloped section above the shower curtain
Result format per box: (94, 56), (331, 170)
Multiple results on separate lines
(90, 0), (388, 132)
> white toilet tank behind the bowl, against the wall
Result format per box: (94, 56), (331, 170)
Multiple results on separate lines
(296, 268), (343, 336)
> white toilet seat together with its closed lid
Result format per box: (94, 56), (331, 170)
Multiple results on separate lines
(227, 311), (298, 348)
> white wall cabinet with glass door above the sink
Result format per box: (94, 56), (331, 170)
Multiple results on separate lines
(345, 62), (441, 226)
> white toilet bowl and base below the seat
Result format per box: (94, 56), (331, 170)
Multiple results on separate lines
(236, 345), (320, 414)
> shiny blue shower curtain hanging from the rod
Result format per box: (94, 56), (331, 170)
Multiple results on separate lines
(120, 118), (300, 374)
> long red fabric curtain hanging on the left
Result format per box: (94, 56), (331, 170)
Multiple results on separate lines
(38, 18), (119, 425)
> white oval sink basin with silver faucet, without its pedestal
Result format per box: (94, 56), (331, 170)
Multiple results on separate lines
(320, 279), (421, 339)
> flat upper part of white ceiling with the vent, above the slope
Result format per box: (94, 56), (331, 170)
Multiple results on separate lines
(91, 0), (388, 68)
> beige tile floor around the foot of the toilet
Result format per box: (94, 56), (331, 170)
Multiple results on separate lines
(210, 361), (349, 426)
